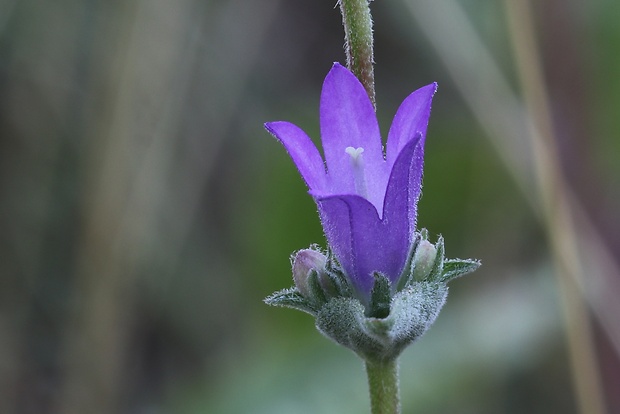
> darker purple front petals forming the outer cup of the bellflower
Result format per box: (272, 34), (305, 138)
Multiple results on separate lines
(316, 134), (424, 300)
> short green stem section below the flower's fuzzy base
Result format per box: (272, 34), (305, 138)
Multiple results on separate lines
(366, 359), (400, 414)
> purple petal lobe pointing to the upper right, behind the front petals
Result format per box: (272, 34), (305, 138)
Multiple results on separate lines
(387, 83), (437, 165)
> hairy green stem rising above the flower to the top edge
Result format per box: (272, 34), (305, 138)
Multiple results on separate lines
(339, 0), (375, 106)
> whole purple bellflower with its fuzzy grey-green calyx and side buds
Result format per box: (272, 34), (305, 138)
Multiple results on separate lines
(265, 63), (480, 363)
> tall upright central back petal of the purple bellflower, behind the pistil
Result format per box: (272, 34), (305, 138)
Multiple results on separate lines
(320, 63), (387, 209)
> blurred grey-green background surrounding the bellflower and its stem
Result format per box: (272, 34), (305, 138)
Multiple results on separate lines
(0, 0), (620, 414)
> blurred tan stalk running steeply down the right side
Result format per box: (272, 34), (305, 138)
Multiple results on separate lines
(504, 0), (605, 414)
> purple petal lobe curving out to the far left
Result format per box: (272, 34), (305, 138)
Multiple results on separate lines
(265, 121), (327, 193)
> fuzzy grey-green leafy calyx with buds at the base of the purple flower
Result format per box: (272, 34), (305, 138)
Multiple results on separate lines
(265, 229), (480, 361)
